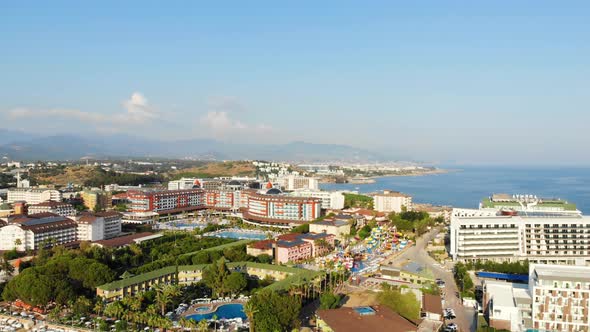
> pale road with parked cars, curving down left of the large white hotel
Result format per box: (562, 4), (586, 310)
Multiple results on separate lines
(383, 228), (477, 332)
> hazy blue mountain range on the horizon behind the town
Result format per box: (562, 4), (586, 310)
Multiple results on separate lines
(0, 129), (392, 162)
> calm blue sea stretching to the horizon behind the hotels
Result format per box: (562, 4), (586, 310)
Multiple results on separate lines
(320, 166), (590, 214)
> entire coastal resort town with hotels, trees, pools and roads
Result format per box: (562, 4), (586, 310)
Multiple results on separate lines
(0, 158), (590, 332)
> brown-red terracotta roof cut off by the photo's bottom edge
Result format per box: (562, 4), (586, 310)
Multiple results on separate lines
(317, 306), (418, 332)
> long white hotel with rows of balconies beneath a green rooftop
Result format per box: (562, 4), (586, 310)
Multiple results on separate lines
(450, 209), (590, 265)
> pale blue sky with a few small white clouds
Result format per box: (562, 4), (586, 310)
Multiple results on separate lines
(0, 1), (590, 164)
